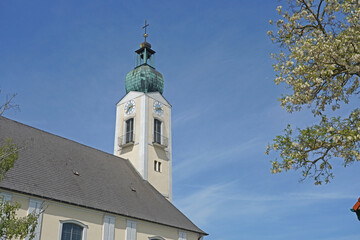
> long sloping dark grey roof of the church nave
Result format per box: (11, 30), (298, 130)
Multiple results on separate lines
(0, 117), (207, 235)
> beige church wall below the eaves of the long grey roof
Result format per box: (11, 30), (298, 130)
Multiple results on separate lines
(2, 191), (199, 240)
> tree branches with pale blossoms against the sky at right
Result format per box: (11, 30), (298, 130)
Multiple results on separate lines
(266, 0), (360, 184)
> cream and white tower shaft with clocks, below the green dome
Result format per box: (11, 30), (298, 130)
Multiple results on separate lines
(114, 91), (172, 201)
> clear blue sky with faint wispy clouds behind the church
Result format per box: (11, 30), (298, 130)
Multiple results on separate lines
(0, 0), (360, 240)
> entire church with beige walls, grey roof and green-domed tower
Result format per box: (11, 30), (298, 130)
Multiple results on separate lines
(0, 33), (207, 240)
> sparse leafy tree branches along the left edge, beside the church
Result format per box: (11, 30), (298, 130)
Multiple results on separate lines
(0, 91), (39, 239)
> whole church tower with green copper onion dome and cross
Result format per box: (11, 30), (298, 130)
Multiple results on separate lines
(114, 21), (172, 201)
